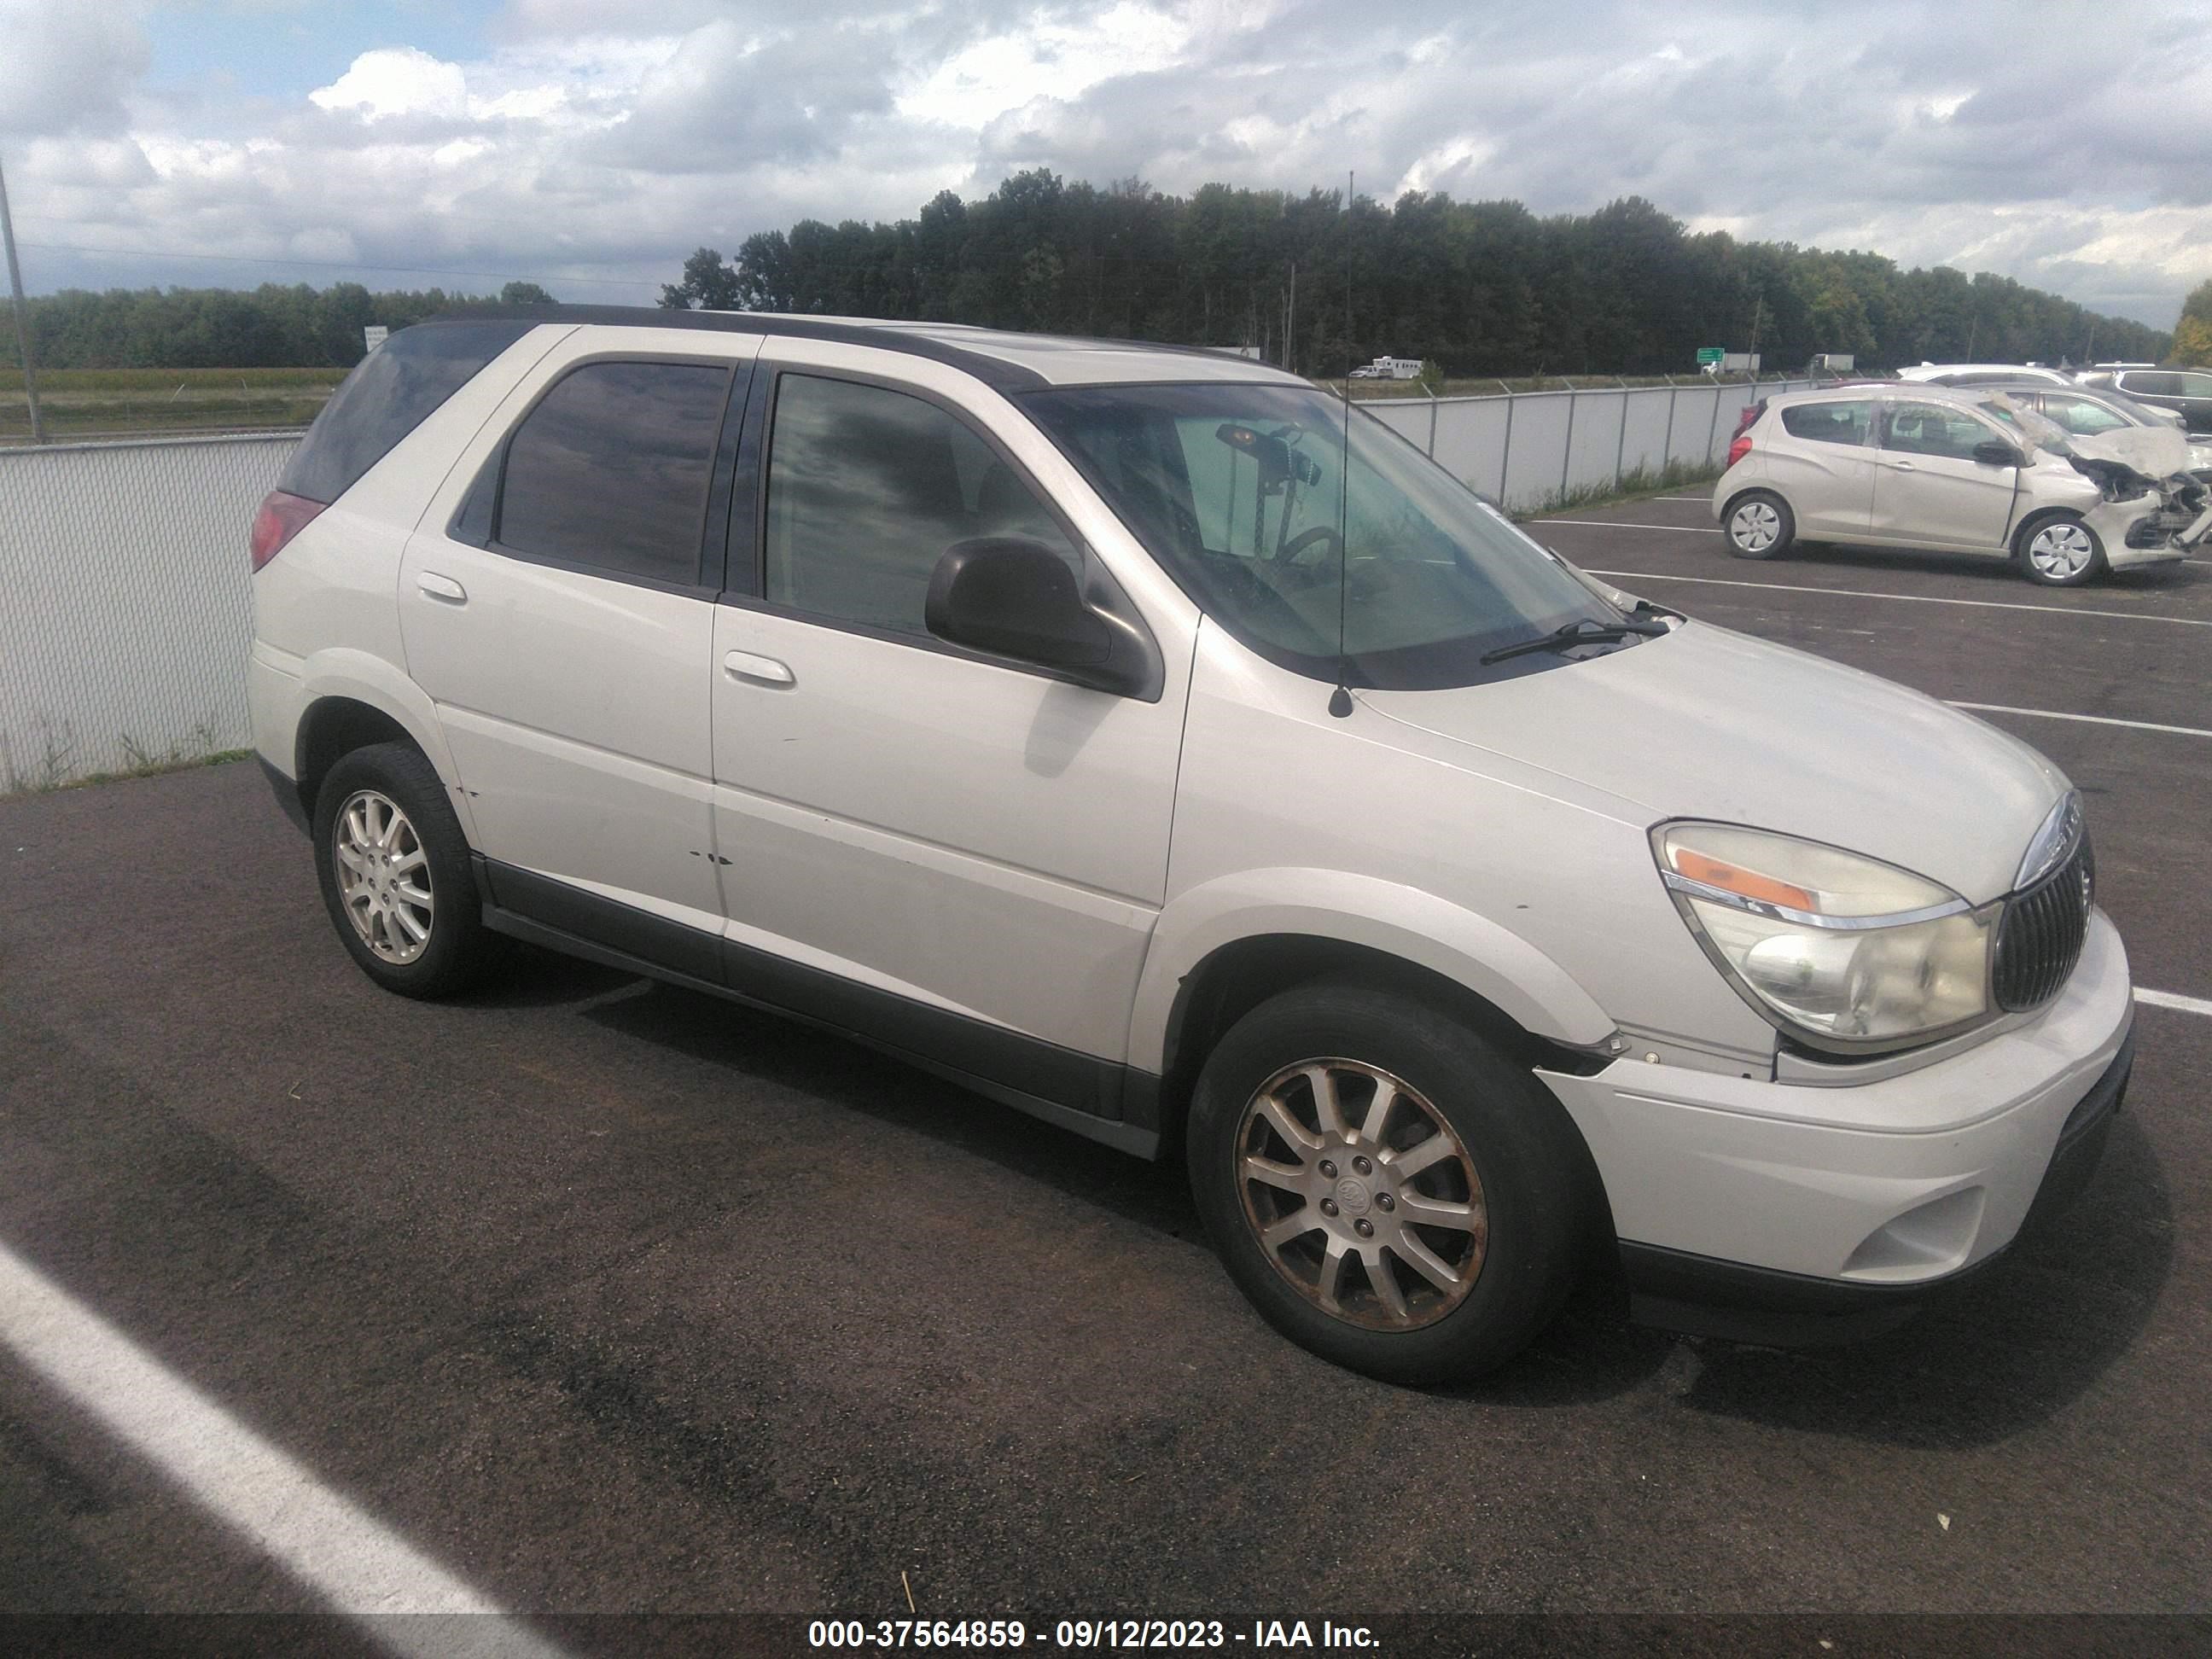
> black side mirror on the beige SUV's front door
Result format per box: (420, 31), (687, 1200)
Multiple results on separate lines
(923, 535), (1150, 695)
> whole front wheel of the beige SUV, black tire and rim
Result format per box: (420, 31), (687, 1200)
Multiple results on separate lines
(1188, 982), (1595, 1382)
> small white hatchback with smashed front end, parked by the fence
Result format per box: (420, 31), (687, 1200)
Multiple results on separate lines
(1712, 385), (2212, 586)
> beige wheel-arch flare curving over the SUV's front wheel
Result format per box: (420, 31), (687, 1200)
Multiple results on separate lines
(1128, 870), (1615, 1073)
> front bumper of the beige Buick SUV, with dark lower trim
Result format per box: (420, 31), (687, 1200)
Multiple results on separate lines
(1540, 911), (2133, 1334)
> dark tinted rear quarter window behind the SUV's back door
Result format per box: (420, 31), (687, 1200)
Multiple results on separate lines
(276, 323), (538, 502)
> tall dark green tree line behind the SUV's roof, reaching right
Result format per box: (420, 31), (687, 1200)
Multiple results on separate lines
(661, 168), (2170, 376)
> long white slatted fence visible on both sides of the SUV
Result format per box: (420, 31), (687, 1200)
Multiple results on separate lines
(0, 381), (1802, 789)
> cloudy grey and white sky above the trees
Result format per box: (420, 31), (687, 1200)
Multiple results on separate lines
(0, 0), (2212, 328)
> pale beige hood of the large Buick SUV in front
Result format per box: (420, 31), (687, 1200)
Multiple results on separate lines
(1360, 621), (2069, 905)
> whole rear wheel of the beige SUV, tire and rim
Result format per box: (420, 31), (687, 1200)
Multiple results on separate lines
(314, 743), (502, 998)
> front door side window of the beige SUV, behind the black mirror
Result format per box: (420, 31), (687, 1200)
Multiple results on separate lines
(765, 374), (1081, 635)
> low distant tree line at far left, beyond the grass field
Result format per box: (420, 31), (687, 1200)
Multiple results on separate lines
(0, 283), (553, 370)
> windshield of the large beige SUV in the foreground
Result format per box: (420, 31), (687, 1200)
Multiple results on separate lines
(1022, 382), (1633, 690)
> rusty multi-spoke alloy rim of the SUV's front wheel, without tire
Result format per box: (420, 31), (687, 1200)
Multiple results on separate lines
(1237, 1060), (1488, 1331)
